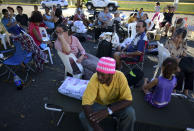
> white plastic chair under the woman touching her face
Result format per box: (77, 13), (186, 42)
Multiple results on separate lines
(57, 50), (83, 78)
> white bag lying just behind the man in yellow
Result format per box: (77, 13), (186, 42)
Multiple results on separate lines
(58, 77), (89, 100)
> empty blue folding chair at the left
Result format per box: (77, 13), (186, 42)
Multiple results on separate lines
(0, 41), (34, 82)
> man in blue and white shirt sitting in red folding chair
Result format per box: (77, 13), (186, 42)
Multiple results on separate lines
(114, 20), (147, 69)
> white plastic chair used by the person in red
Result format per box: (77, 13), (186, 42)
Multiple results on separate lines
(39, 27), (53, 64)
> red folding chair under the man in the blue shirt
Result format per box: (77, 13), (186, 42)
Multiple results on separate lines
(122, 41), (148, 71)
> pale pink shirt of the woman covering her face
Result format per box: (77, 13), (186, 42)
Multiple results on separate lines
(55, 36), (86, 56)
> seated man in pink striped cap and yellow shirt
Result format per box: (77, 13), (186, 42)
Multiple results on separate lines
(79, 57), (136, 131)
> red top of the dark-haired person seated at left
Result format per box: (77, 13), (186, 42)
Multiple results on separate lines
(29, 22), (41, 46)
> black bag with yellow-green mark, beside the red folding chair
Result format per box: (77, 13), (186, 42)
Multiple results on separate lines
(126, 68), (144, 87)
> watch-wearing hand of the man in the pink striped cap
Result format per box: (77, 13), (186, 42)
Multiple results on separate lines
(89, 109), (108, 123)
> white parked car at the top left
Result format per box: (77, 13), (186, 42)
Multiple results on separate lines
(41, 0), (68, 8)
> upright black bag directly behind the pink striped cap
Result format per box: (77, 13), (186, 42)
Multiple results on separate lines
(96, 40), (112, 58)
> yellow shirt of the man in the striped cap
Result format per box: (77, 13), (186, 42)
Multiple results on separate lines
(82, 71), (132, 105)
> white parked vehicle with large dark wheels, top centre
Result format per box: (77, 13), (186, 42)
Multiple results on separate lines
(86, 0), (119, 11)
